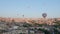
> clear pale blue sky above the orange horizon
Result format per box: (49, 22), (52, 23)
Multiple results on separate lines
(0, 0), (60, 18)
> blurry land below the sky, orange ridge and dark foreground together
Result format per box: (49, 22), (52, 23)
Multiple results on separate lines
(0, 16), (60, 34)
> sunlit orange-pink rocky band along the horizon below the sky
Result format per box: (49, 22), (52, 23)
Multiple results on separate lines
(0, 17), (60, 24)
